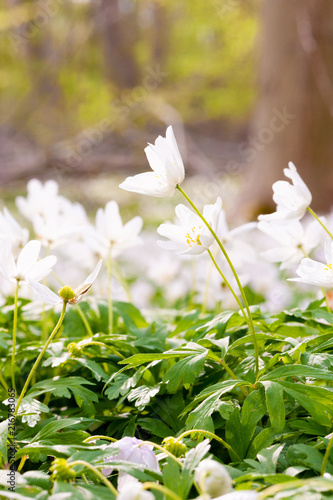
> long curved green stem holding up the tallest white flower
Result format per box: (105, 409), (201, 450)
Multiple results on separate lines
(177, 186), (259, 377)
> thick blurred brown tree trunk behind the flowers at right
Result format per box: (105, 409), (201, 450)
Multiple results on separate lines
(241, 0), (333, 214)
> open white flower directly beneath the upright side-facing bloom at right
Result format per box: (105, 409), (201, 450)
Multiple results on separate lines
(258, 220), (323, 269)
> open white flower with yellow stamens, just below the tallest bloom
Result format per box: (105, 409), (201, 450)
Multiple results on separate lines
(157, 198), (222, 255)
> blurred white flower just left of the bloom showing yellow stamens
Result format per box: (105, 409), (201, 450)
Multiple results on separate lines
(83, 201), (143, 258)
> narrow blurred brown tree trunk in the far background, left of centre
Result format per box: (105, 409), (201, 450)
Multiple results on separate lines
(94, 0), (139, 90)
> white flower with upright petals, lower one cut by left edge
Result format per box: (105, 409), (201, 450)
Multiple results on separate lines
(0, 240), (57, 284)
